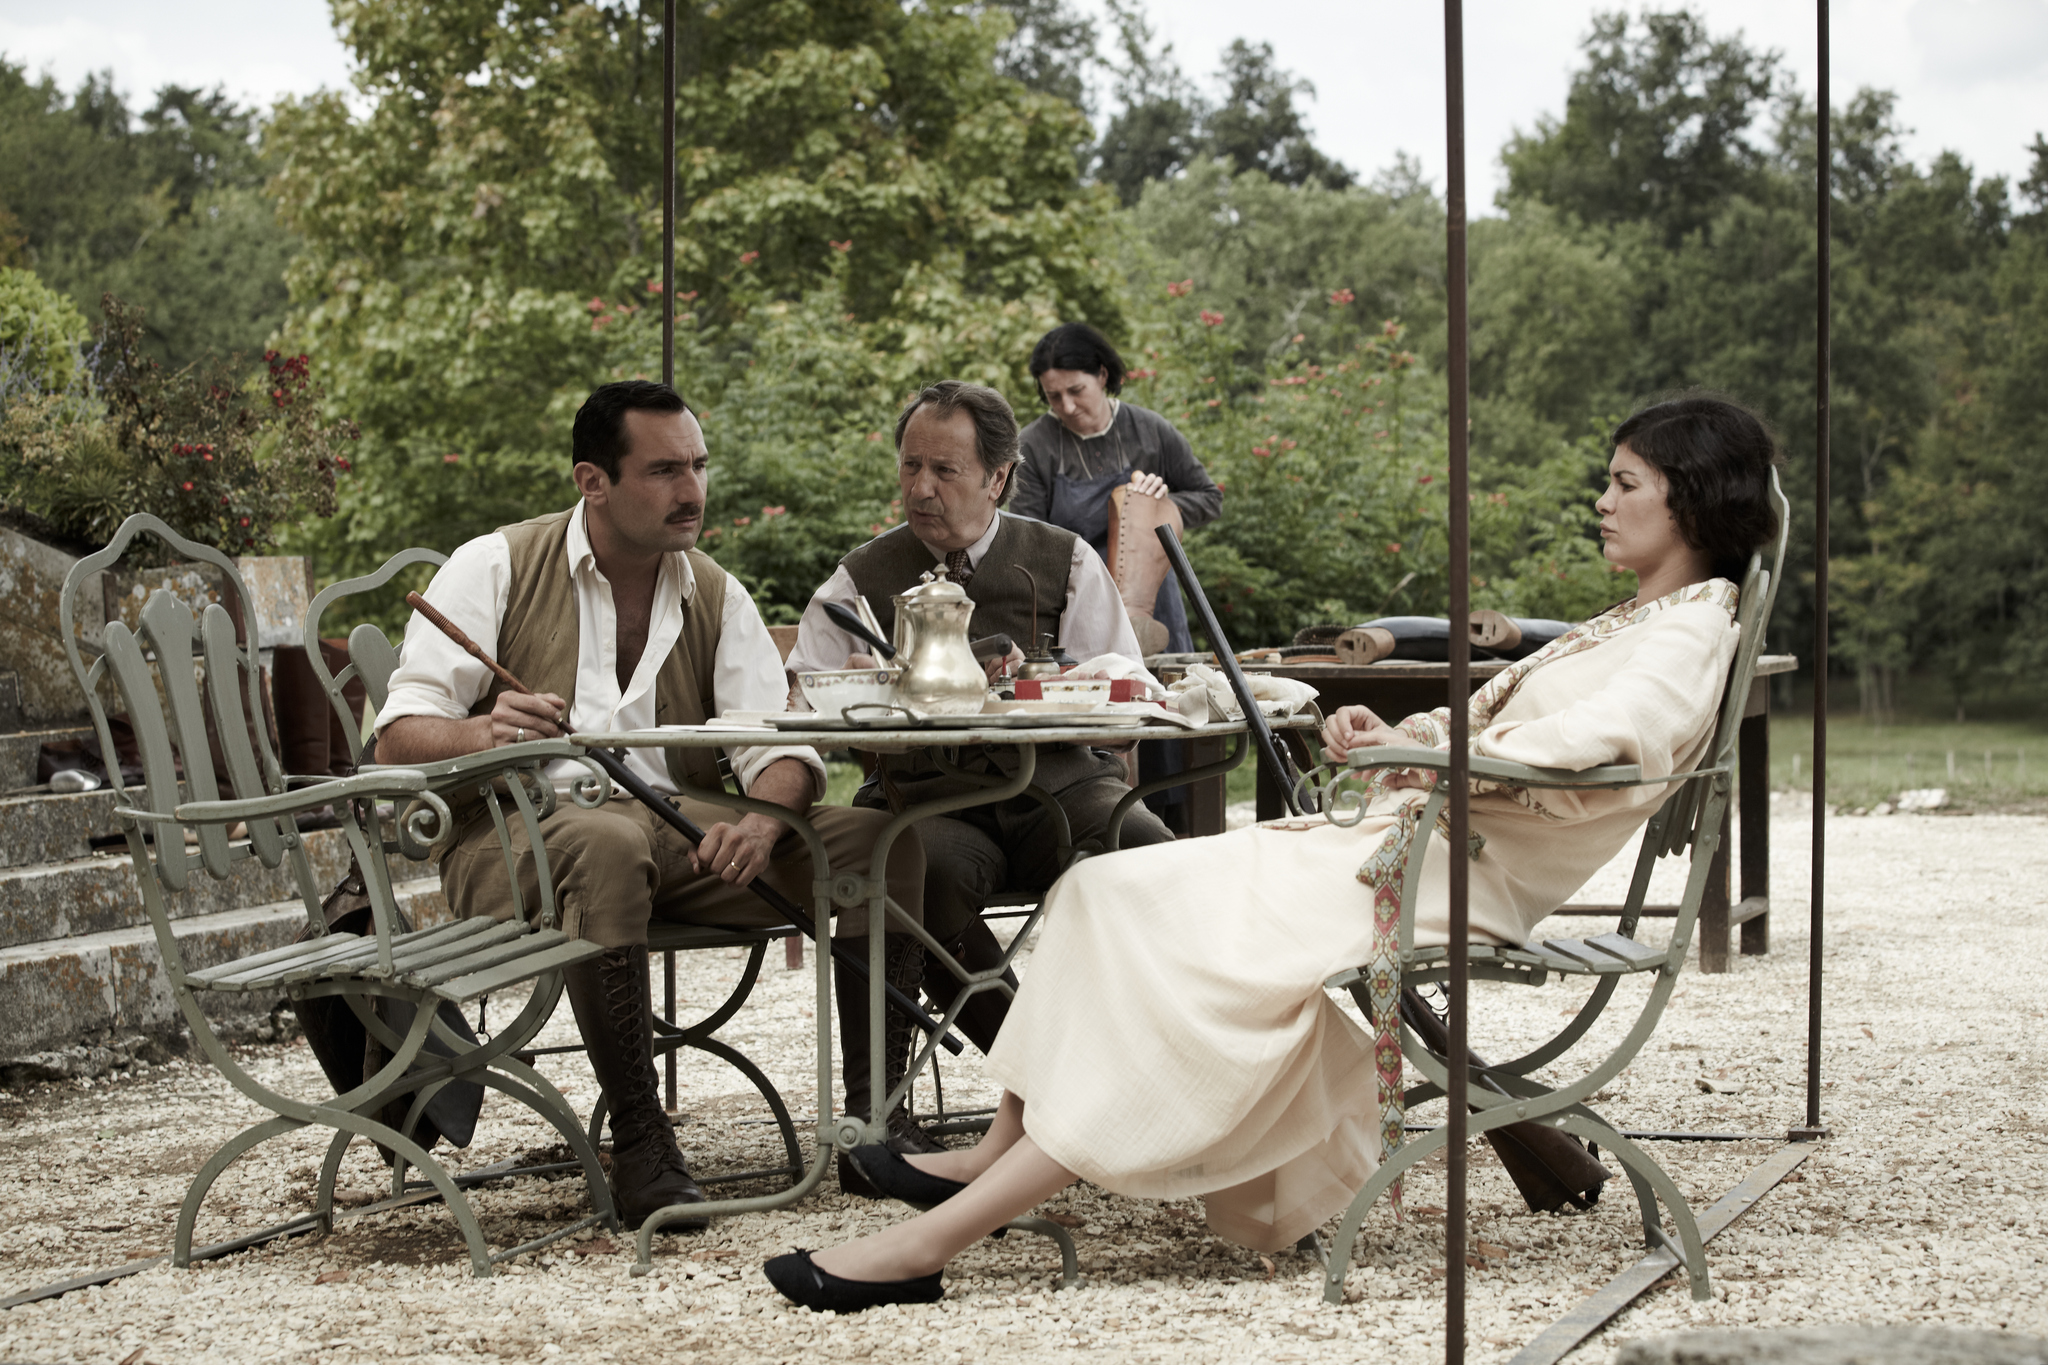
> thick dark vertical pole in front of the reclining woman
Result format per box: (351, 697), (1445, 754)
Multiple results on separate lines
(1421, 0), (1473, 1365)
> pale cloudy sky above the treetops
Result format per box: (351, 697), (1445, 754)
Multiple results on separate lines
(0, 0), (2048, 213)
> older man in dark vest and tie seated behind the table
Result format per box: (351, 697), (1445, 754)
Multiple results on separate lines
(788, 379), (1174, 1195)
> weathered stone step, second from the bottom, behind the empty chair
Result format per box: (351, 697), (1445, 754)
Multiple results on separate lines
(0, 829), (434, 948)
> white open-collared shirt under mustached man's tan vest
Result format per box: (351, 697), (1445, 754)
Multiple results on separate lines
(377, 503), (823, 794)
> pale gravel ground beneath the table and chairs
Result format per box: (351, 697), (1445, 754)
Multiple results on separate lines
(0, 798), (2048, 1365)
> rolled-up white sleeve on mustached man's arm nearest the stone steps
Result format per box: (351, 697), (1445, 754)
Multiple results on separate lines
(377, 534), (512, 733)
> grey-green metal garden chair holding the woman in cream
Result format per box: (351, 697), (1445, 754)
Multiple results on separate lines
(1323, 475), (1790, 1304)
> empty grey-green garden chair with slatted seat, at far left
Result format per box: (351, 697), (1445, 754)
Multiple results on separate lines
(59, 516), (616, 1277)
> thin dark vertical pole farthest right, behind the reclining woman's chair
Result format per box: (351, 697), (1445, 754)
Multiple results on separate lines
(1790, 0), (1835, 1142)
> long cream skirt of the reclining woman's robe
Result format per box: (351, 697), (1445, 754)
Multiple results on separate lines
(989, 817), (1442, 1250)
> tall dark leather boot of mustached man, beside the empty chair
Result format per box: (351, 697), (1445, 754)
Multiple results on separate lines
(563, 943), (711, 1232)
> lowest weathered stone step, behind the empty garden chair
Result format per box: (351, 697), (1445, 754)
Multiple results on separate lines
(0, 878), (449, 1058)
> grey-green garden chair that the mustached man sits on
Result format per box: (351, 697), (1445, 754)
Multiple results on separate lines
(305, 548), (805, 1185)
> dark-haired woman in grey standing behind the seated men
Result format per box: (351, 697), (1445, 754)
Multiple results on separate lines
(1010, 323), (1223, 831)
